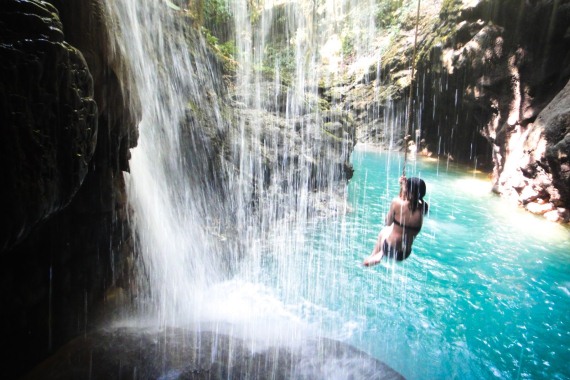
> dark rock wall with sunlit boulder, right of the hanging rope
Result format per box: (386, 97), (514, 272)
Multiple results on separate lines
(418, 1), (570, 222)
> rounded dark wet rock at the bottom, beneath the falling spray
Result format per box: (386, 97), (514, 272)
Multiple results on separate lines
(23, 328), (403, 380)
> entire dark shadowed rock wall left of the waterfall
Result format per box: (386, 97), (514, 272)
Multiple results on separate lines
(0, 0), (137, 378)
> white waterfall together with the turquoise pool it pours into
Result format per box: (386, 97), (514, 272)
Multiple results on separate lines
(103, 0), (570, 379)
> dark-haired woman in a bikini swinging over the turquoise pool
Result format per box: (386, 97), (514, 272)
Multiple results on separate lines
(364, 176), (429, 266)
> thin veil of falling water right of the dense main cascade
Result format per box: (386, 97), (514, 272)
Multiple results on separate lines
(217, 0), (394, 340)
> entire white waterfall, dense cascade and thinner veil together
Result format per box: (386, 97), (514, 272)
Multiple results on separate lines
(107, 0), (390, 342)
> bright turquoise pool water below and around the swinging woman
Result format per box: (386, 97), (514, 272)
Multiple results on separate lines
(255, 150), (570, 379)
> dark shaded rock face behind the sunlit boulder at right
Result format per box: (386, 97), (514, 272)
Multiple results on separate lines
(418, 0), (570, 160)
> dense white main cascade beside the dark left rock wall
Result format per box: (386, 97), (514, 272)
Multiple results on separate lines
(102, 0), (231, 325)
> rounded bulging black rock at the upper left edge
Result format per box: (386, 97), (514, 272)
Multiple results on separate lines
(0, 1), (97, 251)
